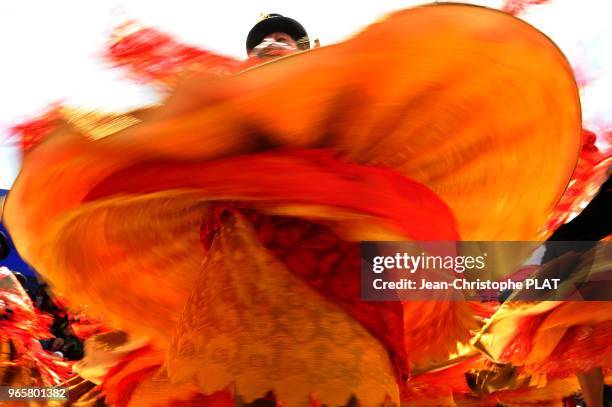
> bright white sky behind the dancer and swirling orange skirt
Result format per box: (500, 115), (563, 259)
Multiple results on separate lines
(0, 0), (612, 189)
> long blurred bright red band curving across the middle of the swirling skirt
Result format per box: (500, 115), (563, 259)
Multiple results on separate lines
(84, 150), (459, 244)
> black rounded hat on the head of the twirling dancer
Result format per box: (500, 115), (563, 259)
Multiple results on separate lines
(246, 14), (310, 52)
